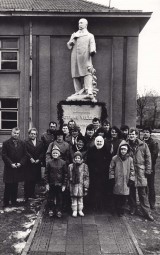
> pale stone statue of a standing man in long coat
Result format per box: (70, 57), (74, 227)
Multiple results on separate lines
(67, 19), (96, 98)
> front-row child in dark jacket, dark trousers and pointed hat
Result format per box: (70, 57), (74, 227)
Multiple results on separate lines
(45, 145), (67, 218)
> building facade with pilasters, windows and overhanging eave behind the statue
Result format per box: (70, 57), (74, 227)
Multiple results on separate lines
(0, 0), (151, 143)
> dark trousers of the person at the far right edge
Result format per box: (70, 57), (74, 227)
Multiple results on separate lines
(147, 171), (156, 208)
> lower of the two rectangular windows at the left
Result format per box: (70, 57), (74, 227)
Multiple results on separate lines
(0, 99), (18, 130)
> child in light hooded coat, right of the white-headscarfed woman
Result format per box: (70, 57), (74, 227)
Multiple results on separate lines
(109, 140), (135, 216)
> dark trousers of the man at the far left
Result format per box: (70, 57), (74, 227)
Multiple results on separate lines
(3, 182), (18, 206)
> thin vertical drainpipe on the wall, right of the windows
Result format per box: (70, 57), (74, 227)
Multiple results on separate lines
(29, 21), (33, 128)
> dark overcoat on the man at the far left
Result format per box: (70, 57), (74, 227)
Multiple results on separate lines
(2, 138), (27, 183)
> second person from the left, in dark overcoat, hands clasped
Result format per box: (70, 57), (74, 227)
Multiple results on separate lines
(24, 128), (45, 202)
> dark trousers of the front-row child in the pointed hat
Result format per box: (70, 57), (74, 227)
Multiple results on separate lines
(47, 185), (62, 212)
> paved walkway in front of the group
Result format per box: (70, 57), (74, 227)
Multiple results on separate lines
(22, 206), (143, 255)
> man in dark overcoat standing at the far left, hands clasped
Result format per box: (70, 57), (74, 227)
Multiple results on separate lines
(2, 127), (27, 207)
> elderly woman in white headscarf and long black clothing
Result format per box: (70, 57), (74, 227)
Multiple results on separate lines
(87, 136), (111, 211)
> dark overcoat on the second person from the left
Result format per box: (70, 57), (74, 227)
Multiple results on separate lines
(25, 139), (45, 182)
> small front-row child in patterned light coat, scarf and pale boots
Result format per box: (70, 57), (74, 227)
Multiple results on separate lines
(68, 151), (89, 217)
